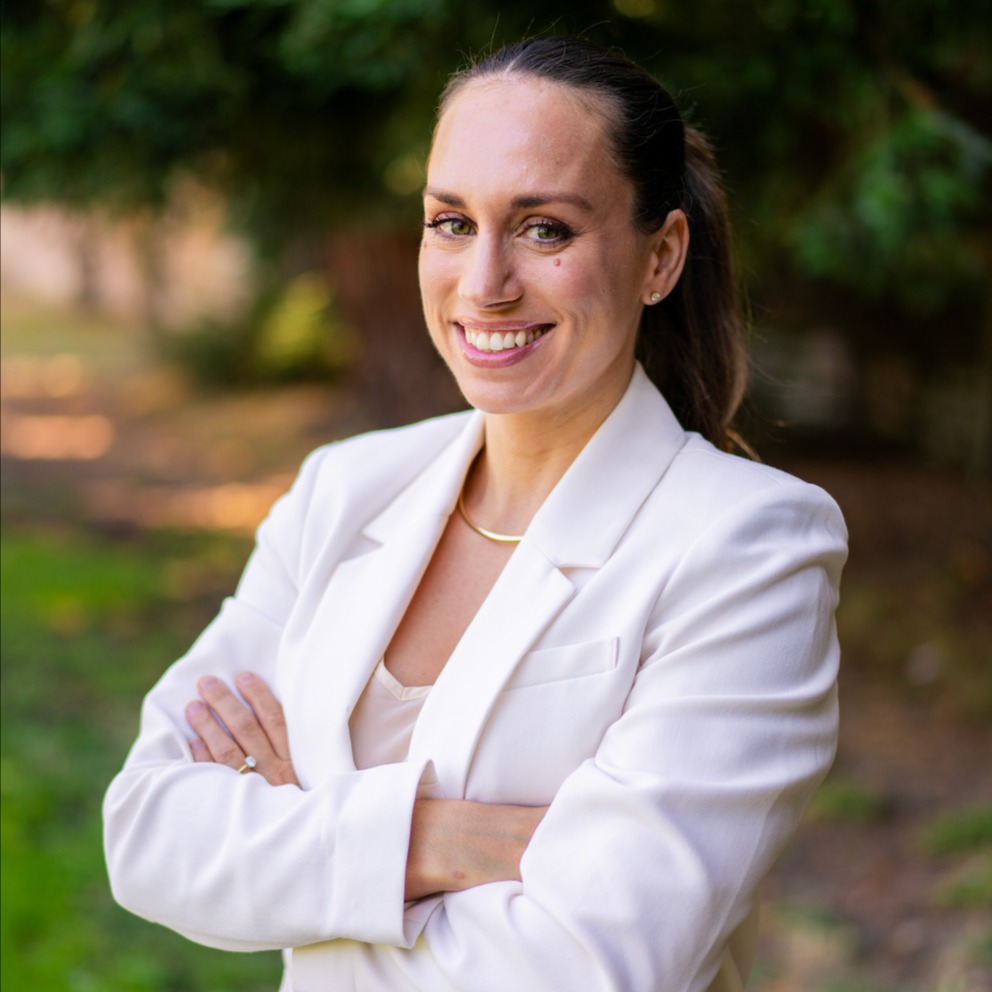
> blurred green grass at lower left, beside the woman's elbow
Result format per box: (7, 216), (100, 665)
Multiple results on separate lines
(0, 530), (279, 992)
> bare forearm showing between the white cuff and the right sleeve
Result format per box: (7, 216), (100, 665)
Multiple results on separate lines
(405, 799), (548, 899)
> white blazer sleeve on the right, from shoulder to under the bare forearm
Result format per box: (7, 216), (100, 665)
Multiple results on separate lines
(334, 480), (846, 992)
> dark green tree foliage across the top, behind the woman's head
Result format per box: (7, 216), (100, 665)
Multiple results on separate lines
(0, 0), (992, 334)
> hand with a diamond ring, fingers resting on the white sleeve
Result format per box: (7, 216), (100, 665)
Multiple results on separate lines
(186, 672), (299, 785)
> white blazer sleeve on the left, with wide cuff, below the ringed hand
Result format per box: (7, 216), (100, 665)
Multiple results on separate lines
(103, 449), (422, 950)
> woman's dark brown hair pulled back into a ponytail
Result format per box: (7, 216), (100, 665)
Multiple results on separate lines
(438, 37), (747, 448)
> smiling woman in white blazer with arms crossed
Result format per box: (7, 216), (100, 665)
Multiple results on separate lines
(105, 38), (846, 992)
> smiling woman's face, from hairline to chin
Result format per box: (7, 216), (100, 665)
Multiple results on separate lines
(420, 77), (659, 429)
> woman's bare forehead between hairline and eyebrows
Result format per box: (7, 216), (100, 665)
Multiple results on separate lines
(428, 76), (626, 207)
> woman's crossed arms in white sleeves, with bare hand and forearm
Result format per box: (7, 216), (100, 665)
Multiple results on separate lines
(105, 446), (842, 992)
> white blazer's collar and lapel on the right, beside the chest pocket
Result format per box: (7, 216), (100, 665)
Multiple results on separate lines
(410, 365), (686, 798)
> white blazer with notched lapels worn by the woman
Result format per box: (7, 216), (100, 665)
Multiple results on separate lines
(105, 367), (846, 992)
